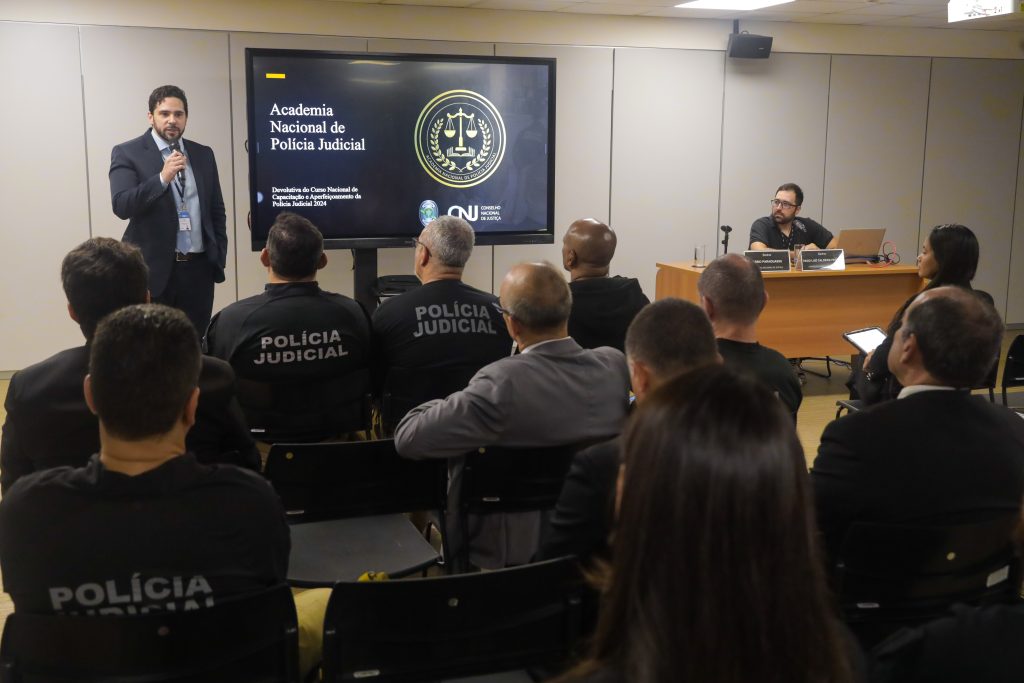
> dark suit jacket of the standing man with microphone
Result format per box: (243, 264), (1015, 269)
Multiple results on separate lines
(110, 130), (227, 298)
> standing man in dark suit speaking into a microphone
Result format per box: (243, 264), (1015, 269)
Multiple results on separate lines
(110, 85), (227, 337)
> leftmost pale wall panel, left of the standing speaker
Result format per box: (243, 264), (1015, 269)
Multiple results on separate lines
(0, 24), (89, 370)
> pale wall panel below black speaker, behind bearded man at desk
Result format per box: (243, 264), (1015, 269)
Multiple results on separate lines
(720, 54), (829, 251)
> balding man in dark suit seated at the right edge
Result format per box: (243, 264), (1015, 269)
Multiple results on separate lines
(811, 287), (1024, 559)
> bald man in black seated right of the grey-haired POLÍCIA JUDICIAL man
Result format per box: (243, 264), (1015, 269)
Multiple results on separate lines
(562, 218), (650, 351)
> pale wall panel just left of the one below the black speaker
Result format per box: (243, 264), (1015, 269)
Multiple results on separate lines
(611, 49), (725, 299)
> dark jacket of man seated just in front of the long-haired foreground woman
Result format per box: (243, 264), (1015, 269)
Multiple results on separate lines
(537, 437), (622, 563)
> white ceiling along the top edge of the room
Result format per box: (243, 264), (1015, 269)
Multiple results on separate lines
(328, 0), (1024, 31)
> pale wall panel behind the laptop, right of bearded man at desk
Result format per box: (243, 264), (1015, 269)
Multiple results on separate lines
(822, 55), (931, 263)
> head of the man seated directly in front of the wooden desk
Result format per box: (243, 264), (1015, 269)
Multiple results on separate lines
(697, 254), (765, 325)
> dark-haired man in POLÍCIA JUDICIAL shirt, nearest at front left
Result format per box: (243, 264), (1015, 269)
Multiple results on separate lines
(0, 304), (289, 614)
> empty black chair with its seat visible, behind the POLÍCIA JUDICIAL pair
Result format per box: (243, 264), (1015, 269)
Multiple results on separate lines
(265, 439), (447, 587)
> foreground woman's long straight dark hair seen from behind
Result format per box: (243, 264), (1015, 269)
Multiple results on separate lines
(560, 366), (852, 683)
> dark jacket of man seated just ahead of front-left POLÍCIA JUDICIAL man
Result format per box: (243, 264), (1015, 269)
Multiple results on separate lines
(0, 346), (259, 493)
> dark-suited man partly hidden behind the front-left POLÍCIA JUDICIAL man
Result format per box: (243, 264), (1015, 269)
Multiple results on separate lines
(0, 238), (259, 494)
